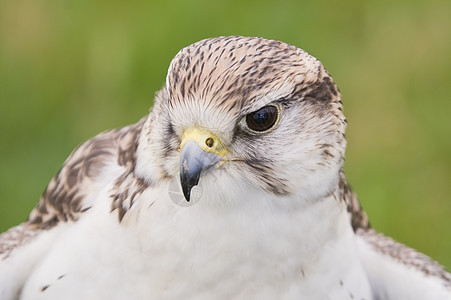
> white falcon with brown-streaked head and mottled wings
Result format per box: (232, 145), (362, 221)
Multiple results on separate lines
(0, 36), (451, 300)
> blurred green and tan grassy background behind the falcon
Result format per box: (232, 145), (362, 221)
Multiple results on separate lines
(0, 0), (451, 270)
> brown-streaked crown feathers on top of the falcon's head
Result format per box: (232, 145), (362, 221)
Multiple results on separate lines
(167, 36), (324, 110)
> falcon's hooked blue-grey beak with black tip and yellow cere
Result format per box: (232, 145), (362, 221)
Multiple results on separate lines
(180, 129), (227, 202)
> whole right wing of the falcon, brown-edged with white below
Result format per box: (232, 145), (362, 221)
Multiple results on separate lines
(339, 172), (451, 300)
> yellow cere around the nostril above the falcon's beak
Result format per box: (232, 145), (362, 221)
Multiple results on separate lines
(180, 127), (229, 157)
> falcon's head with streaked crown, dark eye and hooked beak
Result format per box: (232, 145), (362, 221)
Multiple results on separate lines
(136, 36), (346, 206)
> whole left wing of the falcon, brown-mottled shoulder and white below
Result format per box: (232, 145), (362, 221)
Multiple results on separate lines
(0, 117), (146, 299)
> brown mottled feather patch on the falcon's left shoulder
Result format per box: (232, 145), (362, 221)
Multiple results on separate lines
(26, 118), (146, 229)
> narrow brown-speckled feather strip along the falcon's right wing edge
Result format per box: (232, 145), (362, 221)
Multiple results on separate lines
(356, 228), (451, 289)
